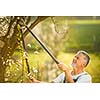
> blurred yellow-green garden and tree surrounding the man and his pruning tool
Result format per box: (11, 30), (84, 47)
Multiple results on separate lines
(0, 16), (100, 83)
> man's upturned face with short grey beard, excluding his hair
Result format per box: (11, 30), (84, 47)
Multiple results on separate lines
(71, 53), (86, 68)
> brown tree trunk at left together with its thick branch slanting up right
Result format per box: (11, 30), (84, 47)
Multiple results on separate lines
(0, 17), (48, 83)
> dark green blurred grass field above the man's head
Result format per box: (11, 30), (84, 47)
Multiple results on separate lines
(65, 21), (100, 51)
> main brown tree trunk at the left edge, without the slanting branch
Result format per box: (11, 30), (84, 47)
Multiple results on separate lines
(0, 20), (18, 82)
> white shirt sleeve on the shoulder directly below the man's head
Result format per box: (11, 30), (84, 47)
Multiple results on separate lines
(76, 75), (92, 83)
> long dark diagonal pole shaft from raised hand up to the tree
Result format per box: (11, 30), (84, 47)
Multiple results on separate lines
(25, 25), (59, 64)
